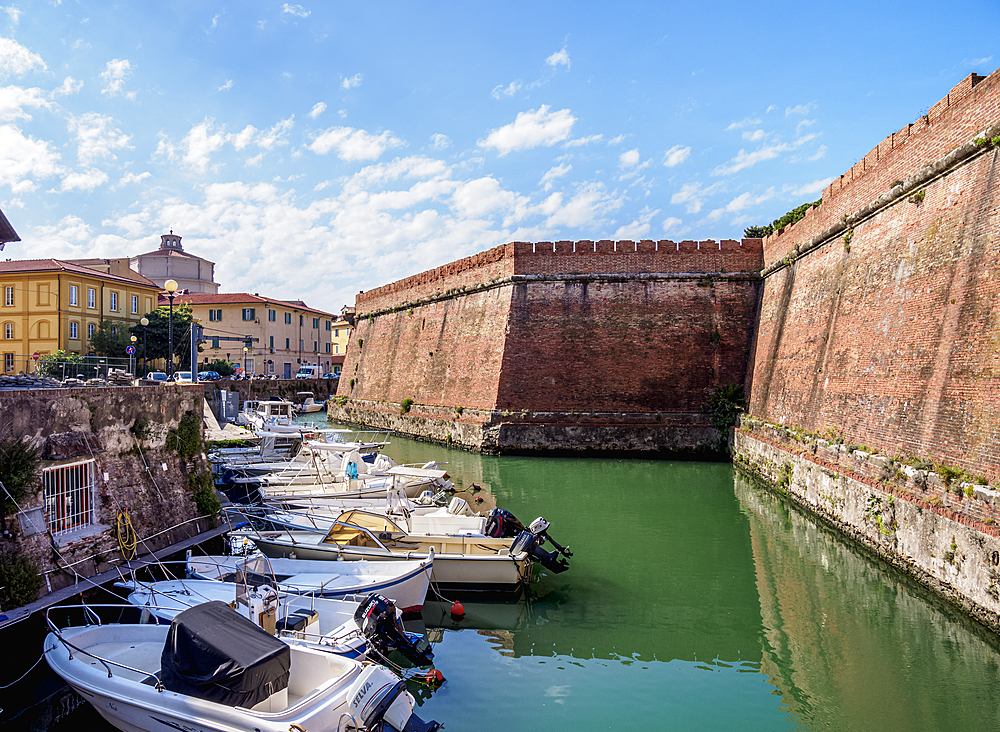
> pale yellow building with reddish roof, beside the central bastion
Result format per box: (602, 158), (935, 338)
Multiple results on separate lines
(174, 292), (338, 379)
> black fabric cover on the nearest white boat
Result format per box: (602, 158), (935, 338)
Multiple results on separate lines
(160, 600), (291, 708)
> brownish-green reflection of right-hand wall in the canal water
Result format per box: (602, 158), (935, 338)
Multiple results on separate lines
(736, 479), (998, 730)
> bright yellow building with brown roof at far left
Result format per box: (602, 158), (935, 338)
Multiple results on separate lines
(0, 259), (159, 374)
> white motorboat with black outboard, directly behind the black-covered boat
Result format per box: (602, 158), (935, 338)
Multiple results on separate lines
(116, 579), (433, 666)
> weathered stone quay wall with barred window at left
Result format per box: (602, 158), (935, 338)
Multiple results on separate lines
(0, 386), (211, 594)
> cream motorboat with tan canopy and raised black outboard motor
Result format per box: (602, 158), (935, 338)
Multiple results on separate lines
(230, 509), (572, 592)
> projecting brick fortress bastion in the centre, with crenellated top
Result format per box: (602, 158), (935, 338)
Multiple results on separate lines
(331, 240), (762, 449)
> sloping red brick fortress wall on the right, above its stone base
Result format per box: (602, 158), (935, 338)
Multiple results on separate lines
(751, 74), (1000, 478)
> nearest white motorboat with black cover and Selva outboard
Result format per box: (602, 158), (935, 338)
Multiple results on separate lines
(43, 601), (439, 732)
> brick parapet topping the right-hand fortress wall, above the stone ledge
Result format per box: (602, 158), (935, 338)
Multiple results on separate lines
(764, 71), (1000, 264)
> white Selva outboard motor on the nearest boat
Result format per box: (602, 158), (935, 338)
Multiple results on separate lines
(348, 666), (441, 732)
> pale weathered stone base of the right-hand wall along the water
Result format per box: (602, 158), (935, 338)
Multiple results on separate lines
(733, 419), (1000, 631)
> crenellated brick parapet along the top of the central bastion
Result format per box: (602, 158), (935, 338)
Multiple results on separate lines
(356, 239), (764, 313)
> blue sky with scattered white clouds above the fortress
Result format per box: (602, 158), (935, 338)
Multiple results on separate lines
(0, 0), (1000, 312)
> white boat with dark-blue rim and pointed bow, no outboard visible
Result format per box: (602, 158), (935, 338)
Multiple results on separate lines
(187, 554), (434, 613)
